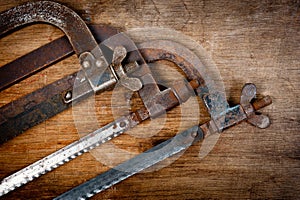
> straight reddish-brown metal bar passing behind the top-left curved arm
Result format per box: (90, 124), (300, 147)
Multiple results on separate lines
(0, 25), (118, 91)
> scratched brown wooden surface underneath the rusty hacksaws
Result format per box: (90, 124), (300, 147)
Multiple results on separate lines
(0, 0), (300, 199)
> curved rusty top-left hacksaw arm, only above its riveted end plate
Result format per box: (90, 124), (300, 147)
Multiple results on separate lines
(0, 1), (97, 56)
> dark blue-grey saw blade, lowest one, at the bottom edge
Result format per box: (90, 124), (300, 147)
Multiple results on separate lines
(55, 126), (204, 200)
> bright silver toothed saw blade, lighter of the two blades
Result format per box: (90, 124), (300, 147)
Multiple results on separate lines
(0, 115), (132, 196)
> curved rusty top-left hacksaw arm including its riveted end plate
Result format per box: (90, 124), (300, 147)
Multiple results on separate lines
(0, 1), (117, 104)
